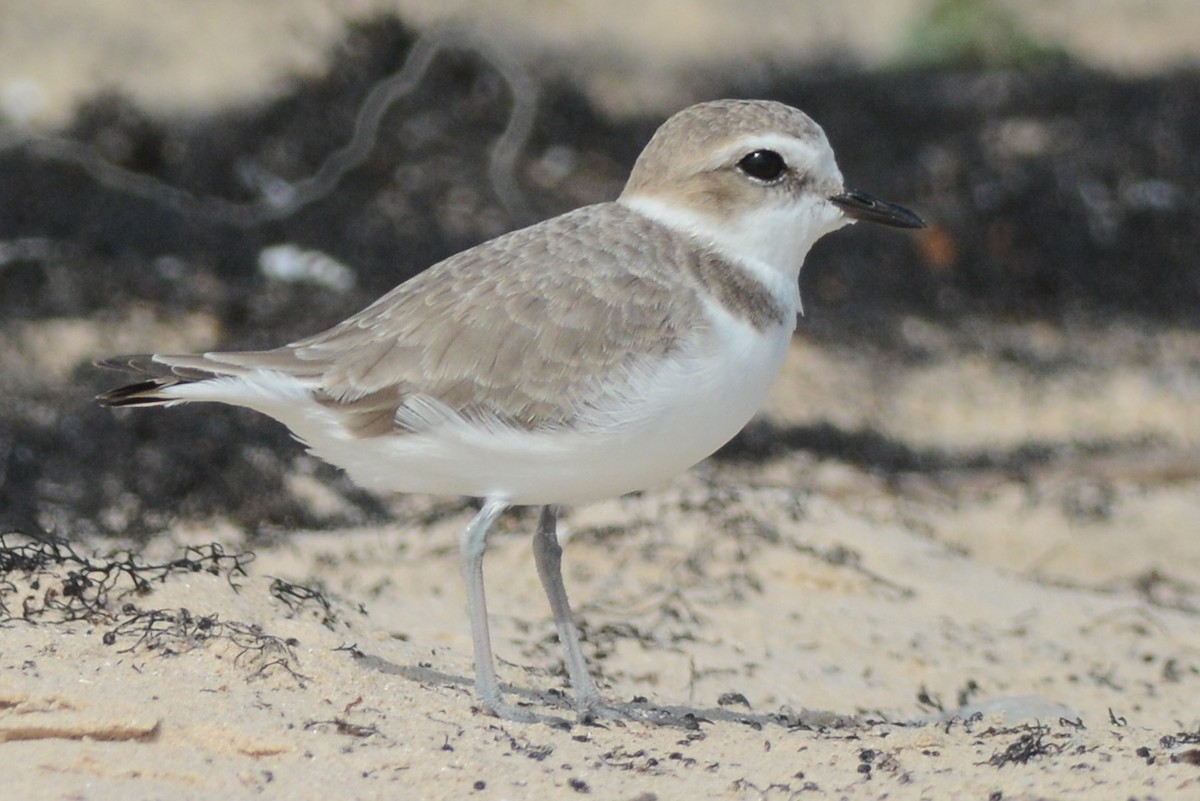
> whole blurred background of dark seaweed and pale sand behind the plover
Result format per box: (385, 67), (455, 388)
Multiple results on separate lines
(0, 0), (1200, 582)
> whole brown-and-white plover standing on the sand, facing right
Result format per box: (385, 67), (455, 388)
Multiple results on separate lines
(100, 101), (924, 719)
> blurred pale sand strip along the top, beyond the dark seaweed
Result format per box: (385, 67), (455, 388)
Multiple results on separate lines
(0, 0), (1200, 126)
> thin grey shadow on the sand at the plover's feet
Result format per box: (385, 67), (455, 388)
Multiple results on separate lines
(346, 646), (865, 730)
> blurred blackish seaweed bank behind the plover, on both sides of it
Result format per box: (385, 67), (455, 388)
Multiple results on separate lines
(0, 20), (1200, 536)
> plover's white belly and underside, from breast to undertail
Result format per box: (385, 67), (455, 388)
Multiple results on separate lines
(175, 309), (792, 505)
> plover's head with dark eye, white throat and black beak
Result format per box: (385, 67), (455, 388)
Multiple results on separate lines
(618, 100), (925, 273)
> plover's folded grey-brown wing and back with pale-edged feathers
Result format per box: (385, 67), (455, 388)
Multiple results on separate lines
(206, 204), (706, 435)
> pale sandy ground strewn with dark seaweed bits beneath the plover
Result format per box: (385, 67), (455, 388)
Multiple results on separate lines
(0, 2), (1200, 801)
